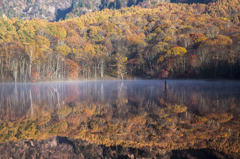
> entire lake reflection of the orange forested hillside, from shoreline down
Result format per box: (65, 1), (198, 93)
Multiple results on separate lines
(0, 80), (240, 157)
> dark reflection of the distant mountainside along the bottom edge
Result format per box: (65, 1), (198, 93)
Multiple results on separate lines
(0, 137), (237, 159)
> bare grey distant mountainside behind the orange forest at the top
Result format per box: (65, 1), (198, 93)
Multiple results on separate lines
(0, 0), (216, 21)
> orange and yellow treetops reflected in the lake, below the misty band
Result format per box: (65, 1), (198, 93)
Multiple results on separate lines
(0, 95), (238, 154)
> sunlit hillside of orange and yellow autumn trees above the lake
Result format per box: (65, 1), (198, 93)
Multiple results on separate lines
(0, 0), (240, 82)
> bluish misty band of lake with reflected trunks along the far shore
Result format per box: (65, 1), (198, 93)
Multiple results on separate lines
(0, 80), (240, 120)
